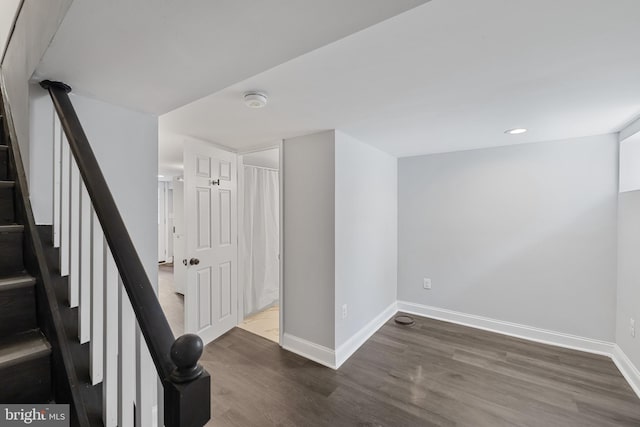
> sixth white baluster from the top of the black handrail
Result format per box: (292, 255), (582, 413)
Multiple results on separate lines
(102, 246), (119, 427)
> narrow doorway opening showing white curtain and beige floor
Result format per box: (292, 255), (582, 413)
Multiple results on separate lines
(238, 147), (282, 343)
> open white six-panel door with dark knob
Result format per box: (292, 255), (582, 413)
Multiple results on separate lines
(184, 141), (238, 344)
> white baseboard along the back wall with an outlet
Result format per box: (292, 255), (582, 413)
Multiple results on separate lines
(398, 301), (614, 357)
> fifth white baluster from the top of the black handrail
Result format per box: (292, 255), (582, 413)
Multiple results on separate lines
(90, 210), (105, 385)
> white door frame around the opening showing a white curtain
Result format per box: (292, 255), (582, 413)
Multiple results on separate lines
(237, 140), (285, 347)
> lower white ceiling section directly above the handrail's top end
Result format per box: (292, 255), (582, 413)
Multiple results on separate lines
(33, 0), (428, 114)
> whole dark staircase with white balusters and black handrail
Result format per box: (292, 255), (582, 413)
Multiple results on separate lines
(0, 79), (211, 427)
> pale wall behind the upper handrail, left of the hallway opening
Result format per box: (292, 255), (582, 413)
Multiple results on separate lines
(25, 86), (158, 286)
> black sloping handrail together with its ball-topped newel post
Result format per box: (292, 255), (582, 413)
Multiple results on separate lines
(40, 80), (211, 427)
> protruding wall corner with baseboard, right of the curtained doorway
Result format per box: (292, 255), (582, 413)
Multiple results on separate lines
(282, 130), (398, 367)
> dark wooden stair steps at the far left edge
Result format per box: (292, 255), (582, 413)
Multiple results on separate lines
(0, 122), (53, 403)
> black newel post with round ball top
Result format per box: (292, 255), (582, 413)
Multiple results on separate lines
(163, 334), (211, 427)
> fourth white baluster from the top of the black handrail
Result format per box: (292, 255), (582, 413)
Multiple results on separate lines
(78, 181), (92, 344)
